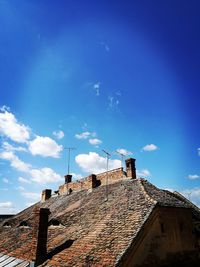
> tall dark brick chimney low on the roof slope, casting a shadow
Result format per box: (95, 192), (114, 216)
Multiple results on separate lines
(31, 207), (50, 266)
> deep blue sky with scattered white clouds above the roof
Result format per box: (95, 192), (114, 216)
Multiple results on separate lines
(0, 0), (200, 213)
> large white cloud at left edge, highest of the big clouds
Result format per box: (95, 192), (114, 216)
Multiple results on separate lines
(0, 106), (30, 143)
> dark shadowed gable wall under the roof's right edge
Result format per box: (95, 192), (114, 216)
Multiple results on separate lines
(120, 207), (198, 267)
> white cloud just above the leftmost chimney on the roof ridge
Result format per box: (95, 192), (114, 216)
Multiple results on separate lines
(30, 167), (62, 184)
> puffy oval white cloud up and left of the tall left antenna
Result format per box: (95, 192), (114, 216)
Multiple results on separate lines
(29, 136), (63, 158)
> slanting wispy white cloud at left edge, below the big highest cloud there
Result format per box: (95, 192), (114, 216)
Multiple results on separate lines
(0, 151), (31, 172)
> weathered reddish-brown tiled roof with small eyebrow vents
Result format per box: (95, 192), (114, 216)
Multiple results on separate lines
(0, 179), (196, 267)
